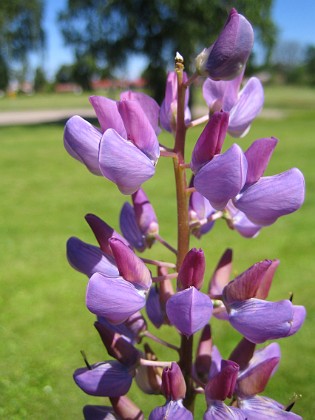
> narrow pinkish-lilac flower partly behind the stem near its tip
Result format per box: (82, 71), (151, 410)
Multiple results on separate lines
(160, 71), (191, 133)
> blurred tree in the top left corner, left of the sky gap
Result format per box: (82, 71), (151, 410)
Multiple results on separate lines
(0, 0), (45, 76)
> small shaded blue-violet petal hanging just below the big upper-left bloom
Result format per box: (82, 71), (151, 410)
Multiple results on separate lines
(119, 202), (146, 252)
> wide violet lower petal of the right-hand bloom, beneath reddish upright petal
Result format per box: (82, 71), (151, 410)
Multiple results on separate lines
(229, 298), (306, 344)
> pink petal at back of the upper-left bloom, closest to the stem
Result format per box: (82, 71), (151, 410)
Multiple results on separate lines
(120, 90), (161, 135)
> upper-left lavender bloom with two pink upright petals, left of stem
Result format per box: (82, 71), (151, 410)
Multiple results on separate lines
(64, 96), (160, 194)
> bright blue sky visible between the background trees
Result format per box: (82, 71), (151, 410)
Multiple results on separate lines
(32, 0), (315, 78)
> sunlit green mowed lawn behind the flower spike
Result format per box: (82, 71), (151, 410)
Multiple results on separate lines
(0, 87), (315, 420)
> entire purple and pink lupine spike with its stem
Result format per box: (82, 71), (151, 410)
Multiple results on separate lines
(64, 9), (306, 420)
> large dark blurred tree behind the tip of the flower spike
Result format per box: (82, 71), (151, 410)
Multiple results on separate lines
(59, 0), (276, 99)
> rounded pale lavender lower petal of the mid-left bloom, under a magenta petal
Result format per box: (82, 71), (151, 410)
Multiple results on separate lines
(86, 273), (145, 324)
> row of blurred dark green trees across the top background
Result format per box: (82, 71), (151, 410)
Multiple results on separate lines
(0, 0), (315, 100)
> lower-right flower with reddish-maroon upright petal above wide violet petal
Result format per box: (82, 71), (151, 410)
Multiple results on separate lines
(223, 260), (306, 343)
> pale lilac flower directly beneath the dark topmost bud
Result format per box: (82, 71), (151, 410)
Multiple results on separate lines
(203, 72), (264, 137)
